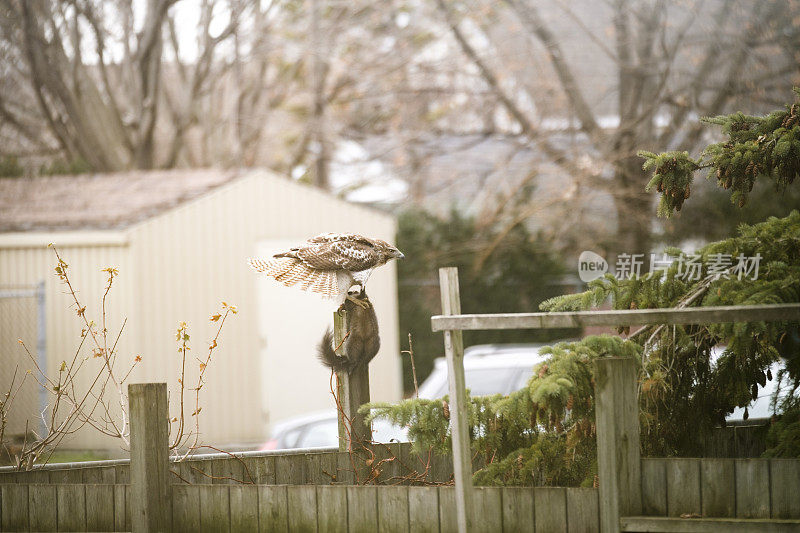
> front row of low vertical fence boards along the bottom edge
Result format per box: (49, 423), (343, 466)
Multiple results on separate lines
(0, 484), (599, 533)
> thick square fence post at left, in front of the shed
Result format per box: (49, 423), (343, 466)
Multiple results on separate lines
(128, 383), (172, 532)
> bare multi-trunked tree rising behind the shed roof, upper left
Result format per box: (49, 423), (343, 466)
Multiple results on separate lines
(0, 0), (272, 171)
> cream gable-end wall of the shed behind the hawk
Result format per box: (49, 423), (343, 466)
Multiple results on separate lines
(130, 172), (401, 443)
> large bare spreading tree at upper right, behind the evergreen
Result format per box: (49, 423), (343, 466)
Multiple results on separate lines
(437, 0), (800, 252)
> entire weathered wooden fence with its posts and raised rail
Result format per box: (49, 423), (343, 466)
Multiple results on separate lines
(0, 269), (800, 533)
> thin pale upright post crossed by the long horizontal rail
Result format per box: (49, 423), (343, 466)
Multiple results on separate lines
(439, 267), (474, 533)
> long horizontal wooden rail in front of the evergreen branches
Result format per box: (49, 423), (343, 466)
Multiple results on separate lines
(431, 303), (800, 331)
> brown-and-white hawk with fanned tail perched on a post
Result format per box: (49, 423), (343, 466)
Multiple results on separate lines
(248, 233), (403, 302)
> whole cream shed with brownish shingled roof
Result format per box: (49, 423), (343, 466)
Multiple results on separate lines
(0, 170), (402, 449)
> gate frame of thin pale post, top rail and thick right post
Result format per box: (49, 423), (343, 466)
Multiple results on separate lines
(431, 267), (800, 533)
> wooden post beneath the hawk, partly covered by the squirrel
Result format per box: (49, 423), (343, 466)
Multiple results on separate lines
(333, 311), (372, 452)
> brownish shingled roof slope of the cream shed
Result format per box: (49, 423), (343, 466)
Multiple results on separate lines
(0, 169), (240, 232)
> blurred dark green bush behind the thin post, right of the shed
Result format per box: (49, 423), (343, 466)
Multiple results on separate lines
(397, 209), (578, 393)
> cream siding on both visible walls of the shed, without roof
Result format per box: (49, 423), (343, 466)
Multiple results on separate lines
(0, 171), (401, 448)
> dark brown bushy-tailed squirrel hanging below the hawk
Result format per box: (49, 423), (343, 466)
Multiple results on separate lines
(319, 287), (381, 374)
